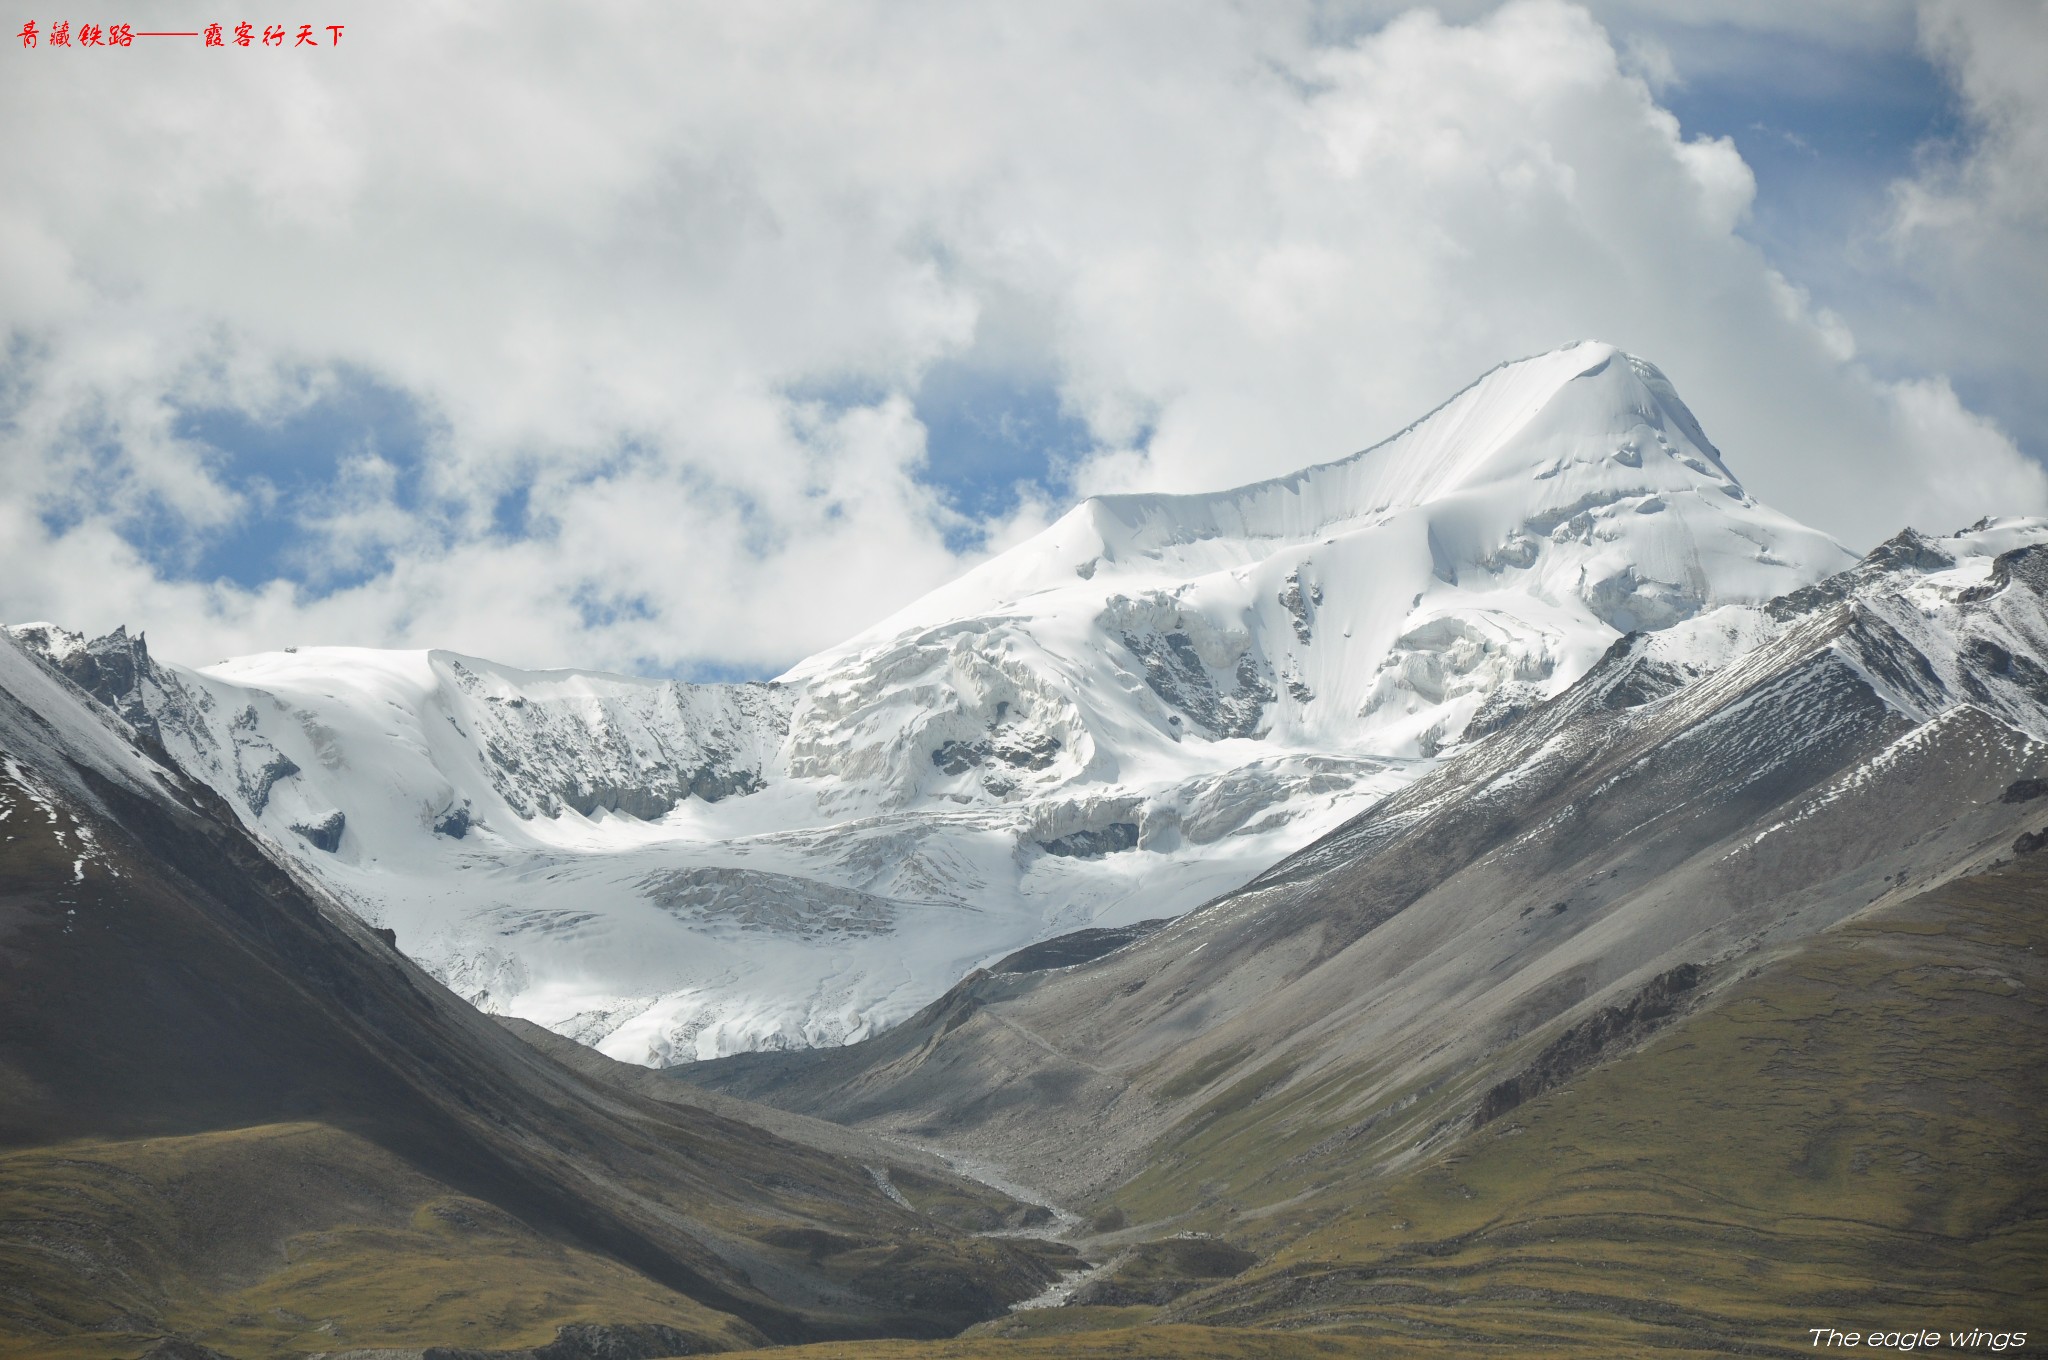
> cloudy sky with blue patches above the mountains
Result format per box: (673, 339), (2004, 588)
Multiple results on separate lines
(0, 0), (2048, 680)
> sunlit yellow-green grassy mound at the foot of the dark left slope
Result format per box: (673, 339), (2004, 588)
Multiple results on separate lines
(0, 1124), (760, 1360)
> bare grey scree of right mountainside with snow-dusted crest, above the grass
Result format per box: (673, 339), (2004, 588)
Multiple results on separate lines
(684, 518), (2048, 1228)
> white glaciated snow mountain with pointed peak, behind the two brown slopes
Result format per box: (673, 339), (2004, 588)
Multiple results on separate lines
(12, 344), (1855, 1065)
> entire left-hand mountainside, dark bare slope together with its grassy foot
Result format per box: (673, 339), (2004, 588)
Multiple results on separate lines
(0, 639), (1067, 1360)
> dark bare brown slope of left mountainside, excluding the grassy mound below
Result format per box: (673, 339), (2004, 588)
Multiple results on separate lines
(0, 630), (1081, 1344)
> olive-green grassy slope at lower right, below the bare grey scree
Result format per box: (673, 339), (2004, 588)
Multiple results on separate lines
(720, 856), (2048, 1360)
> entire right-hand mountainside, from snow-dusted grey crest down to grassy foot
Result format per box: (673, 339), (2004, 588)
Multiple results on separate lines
(688, 522), (2048, 1354)
